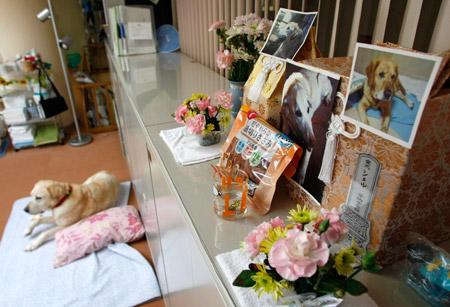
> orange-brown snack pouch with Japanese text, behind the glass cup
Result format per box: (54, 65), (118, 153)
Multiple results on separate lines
(219, 105), (303, 214)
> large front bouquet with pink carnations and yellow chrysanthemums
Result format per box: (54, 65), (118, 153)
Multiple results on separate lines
(233, 205), (381, 306)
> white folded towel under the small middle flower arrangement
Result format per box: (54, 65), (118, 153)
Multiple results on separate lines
(159, 127), (226, 165)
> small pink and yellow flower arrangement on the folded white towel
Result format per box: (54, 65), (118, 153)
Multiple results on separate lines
(172, 90), (233, 145)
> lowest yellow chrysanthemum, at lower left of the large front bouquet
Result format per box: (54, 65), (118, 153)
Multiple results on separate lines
(252, 264), (289, 301)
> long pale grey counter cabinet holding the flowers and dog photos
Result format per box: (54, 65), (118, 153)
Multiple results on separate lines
(108, 49), (436, 306)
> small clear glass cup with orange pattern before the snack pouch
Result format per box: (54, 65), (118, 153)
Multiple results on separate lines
(213, 168), (248, 220)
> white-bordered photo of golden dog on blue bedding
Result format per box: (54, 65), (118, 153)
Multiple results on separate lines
(342, 43), (441, 148)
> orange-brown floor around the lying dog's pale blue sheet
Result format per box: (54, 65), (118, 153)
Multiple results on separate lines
(0, 129), (164, 307)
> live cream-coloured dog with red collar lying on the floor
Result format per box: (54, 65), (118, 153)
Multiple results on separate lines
(24, 171), (120, 251)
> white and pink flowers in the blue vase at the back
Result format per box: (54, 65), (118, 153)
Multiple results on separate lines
(209, 13), (272, 82)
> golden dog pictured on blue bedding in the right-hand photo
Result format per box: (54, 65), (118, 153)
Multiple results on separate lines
(357, 58), (414, 133)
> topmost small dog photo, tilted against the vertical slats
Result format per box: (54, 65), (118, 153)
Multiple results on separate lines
(261, 9), (317, 59)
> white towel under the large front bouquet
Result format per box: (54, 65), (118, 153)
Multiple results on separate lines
(216, 249), (378, 307)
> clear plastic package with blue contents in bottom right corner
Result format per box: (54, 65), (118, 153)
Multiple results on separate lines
(404, 232), (450, 306)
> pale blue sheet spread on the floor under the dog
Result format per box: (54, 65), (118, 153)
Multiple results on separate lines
(0, 182), (161, 307)
